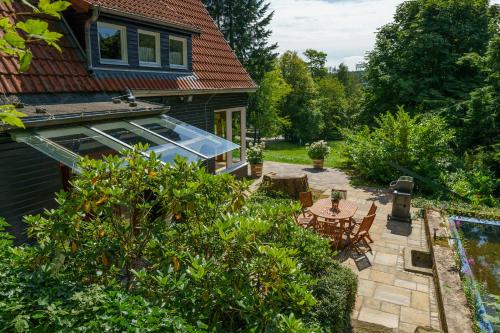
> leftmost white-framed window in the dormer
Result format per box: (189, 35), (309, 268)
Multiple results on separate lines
(97, 22), (128, 65)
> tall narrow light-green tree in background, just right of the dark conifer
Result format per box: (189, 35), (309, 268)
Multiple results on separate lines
(279, 51), (324, 143)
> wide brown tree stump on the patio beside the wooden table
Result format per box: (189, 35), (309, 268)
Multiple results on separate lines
(262, 172), (309, 199)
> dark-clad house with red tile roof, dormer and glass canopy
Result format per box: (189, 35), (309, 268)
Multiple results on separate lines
(0, 0), (256, 242)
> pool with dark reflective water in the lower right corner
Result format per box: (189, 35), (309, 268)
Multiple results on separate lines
(449, 216), (500, 333)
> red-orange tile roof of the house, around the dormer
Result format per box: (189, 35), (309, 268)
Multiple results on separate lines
(0, 0), (255, 94)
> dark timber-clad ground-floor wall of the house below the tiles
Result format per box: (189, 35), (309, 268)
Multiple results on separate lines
(0, 93), (248, 244)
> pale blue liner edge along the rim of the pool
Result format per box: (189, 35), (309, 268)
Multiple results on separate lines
(448, 216), (500, 333)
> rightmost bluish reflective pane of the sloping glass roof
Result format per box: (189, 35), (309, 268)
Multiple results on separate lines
(131, 115), (240, 158)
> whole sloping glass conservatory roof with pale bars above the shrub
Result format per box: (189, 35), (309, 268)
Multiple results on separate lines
(11, 115), (239, 171)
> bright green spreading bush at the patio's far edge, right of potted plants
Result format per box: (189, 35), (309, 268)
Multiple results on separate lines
(346, 108), (454, 183)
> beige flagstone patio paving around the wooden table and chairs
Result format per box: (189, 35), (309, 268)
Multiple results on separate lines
(252, 162), (441, 333)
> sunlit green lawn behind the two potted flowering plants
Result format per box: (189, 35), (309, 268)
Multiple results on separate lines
(264, 141), (347, 168)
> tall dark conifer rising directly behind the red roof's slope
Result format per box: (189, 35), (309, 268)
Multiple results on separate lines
(203, 0), (278, 83)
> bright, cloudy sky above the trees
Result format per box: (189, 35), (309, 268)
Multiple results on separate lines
(269, 0), (500, 70)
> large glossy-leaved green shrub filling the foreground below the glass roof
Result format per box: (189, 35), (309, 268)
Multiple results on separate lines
(0, 150), (356, 332)
